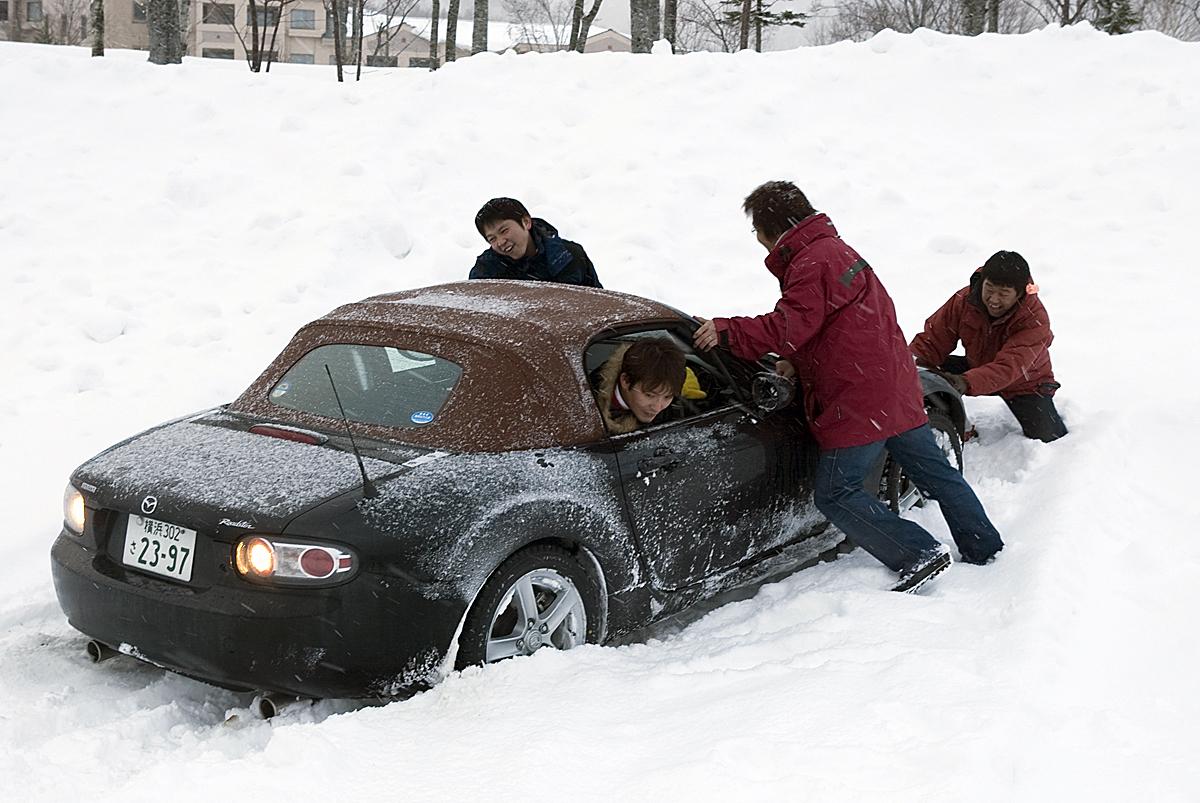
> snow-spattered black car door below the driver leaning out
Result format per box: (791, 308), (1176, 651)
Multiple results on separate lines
(600, 332), (821, 589)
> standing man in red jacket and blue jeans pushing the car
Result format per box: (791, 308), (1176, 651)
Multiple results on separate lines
(695, 181), (1003, 591)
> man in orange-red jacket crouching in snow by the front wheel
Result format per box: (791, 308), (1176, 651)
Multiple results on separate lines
(910, 251), (1067, 443)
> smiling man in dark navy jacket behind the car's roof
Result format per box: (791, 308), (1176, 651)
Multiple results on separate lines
(470, 198), (602, 287)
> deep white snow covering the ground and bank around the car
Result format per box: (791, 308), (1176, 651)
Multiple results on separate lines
(0, 26), (1200, 803)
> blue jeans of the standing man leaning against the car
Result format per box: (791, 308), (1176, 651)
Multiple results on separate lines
(816, 424), (1004, 571)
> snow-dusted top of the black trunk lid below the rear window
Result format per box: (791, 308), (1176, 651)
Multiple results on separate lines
(74, 412), (403, 527)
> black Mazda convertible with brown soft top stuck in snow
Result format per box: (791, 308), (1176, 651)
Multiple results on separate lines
(52, 281), (964, 696)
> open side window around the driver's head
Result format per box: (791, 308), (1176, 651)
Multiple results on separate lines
(583, 329), (738, 424)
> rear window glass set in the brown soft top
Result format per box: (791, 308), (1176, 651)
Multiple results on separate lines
(270, 343), (462, 429)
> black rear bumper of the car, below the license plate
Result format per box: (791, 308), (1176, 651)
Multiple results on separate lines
(50, 532), (467, 697)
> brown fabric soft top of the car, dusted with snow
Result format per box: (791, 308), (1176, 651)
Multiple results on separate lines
(230, 280), (680, 451)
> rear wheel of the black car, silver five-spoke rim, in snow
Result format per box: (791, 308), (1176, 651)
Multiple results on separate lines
(455, 544), (604, 670)
